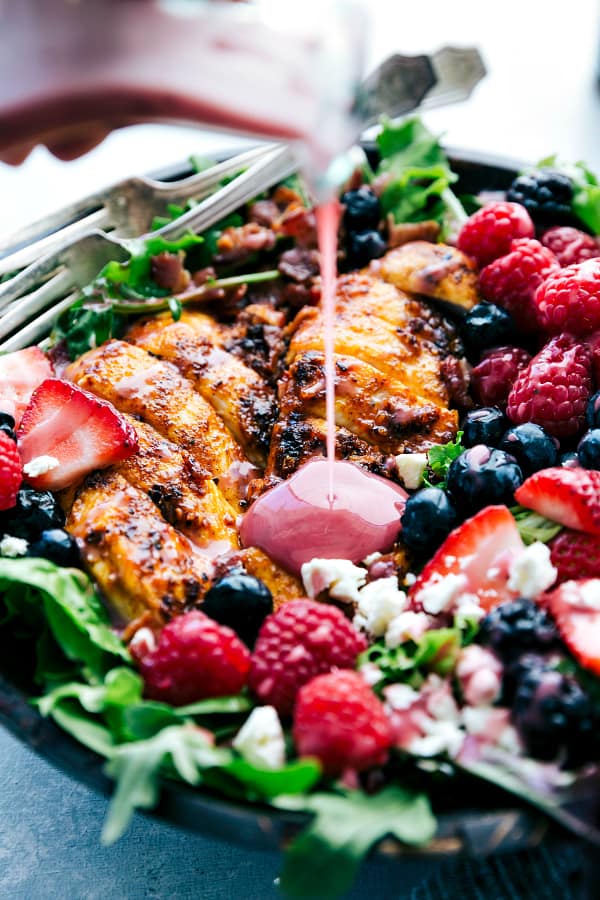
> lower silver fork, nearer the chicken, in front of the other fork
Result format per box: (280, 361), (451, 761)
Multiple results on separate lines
(0, 146), (297, 352)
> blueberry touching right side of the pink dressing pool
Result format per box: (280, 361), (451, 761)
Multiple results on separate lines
(402, 488), (458, 551)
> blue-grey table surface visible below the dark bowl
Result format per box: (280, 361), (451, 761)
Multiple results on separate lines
(0, 728), (592, 900)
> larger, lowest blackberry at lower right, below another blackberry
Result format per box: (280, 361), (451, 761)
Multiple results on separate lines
(512, 666), (600, 769)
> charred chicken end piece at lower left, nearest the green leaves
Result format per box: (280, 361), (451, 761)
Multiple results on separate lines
(66, 471), (211, 625)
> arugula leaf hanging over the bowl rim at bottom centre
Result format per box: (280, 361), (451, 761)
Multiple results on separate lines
(274, 786), (436, 897)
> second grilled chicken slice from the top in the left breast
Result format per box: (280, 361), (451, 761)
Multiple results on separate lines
(65, 340), (244, 505)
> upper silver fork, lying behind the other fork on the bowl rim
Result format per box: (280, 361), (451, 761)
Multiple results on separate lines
(0, 144), (276, 278)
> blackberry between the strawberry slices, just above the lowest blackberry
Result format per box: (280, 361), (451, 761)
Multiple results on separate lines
(478, 598), (559, 662)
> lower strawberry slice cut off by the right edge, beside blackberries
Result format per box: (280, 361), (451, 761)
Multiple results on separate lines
(543, 578), (600, 675)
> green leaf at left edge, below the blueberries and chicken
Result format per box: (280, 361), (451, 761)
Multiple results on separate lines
(0, 557), (130, 675)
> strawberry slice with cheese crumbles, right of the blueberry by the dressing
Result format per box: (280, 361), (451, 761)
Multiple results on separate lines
(409, 506), (523, 610)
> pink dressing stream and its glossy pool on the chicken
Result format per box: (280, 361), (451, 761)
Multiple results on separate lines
(240, 200), (407, 573)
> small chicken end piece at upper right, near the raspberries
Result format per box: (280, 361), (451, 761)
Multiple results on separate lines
(375, 241), (481, 312)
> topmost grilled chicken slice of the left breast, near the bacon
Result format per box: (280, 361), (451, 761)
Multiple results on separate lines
(127, 316), (277, 468)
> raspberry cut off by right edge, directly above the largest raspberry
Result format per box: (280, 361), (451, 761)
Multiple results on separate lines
(535, 259), (600, 335)
